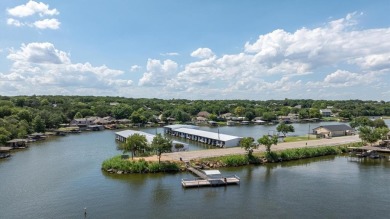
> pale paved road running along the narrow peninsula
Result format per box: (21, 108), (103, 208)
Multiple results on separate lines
(161, 135), (360, 160)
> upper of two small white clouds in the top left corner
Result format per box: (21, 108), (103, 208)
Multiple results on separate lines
(7, 0), (59, 17)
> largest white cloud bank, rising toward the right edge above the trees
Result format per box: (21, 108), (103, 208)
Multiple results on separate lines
(139, 12), (390, 98)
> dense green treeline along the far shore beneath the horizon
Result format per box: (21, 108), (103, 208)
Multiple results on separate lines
(0, 95), (390, 144)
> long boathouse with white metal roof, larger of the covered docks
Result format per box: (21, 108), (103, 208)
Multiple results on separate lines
(164, 125), (242, 147)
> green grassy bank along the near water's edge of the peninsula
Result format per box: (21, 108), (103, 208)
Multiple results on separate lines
(102, 142), (362, 174)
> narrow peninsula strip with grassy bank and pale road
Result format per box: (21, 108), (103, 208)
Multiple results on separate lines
(102, 136), (361, 174)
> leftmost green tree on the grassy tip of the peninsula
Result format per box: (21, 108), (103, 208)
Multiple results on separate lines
(118, 133), (148, 159)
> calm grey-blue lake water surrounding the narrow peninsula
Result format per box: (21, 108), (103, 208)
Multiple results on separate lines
(0, 122), (390, 219)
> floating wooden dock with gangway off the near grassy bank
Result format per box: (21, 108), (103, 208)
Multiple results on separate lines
(181, 162), (240, 188)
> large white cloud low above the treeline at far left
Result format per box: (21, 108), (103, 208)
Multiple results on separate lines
(0, 42), (133, 94)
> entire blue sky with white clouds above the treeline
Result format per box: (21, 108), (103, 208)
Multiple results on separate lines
(0, 0), (390, 101)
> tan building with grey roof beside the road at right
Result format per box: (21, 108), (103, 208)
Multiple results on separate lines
(313, 124), (354, 138)
